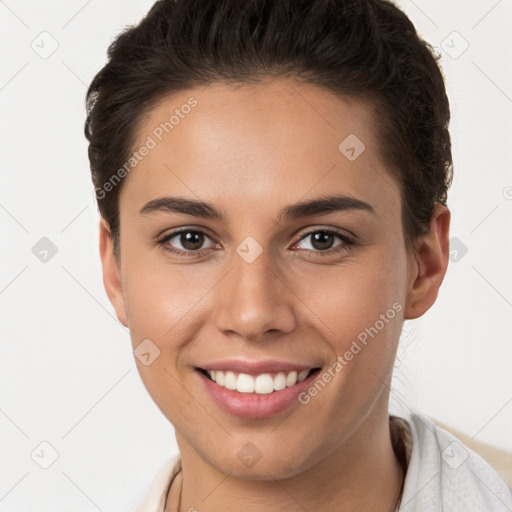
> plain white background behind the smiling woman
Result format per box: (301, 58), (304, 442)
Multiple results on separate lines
(0, 0), (512, 512)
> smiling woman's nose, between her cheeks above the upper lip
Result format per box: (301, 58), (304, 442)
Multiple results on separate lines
(216, 245), (296, 341)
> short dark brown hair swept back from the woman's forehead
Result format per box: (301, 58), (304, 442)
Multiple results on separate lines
(85, 0), (452, 254)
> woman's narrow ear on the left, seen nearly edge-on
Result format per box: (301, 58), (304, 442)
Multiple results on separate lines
(100, 217), (128, 327)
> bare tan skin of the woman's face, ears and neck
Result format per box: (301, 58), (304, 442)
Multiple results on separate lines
(100, 80), (450, 512)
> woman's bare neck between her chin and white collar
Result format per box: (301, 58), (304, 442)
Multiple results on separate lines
(166, 411), (405, 512)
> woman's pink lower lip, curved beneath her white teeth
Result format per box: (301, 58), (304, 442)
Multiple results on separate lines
(196, 370), (318, 419)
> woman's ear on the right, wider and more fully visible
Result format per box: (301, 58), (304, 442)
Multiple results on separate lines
(404, 204), (451, 320)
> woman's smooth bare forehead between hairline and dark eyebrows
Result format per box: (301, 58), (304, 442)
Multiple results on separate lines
(120, 80), (400, 222)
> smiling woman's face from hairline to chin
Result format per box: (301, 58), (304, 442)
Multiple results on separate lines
(102, 81), (448, 479)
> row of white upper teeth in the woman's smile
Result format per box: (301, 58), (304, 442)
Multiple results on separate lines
(207, 370), (310, 395)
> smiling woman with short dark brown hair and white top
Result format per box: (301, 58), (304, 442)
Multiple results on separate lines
(85, 0), (512, 512)
